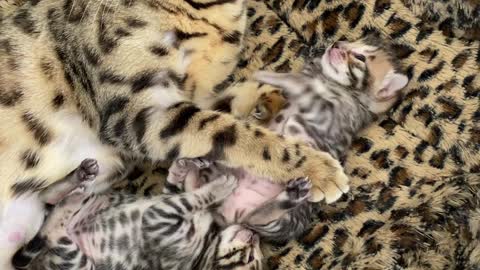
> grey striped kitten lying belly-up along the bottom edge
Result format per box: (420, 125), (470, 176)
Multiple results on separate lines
(13, 160), (262, 270)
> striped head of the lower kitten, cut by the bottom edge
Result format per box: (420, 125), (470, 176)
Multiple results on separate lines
(214, 225), (263, 270)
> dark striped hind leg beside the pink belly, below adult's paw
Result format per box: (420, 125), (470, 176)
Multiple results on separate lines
(243, 178), (313, 241)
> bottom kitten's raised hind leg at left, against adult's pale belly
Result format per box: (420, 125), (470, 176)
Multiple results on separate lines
(39, 159), (99, 204)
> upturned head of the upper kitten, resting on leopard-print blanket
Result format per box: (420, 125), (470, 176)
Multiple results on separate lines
(314, 39), (408, 113)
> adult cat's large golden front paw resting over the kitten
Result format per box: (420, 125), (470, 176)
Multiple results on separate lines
(304, 149), (350, 203)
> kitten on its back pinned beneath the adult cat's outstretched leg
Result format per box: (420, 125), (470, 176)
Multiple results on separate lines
(167, 36), (408, 241)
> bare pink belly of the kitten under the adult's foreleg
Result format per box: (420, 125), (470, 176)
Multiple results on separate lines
(220, 171), (285, 224)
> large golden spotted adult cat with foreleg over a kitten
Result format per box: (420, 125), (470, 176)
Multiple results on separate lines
(0, 0), (348, 270)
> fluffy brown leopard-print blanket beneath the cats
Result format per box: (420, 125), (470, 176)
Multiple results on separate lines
(0, 0), (480, 269)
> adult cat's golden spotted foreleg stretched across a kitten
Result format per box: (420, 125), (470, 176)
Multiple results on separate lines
(101, 87), (349, 202)
